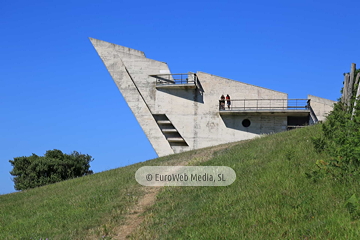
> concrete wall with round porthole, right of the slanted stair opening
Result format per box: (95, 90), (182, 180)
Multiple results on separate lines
(155, 72), (287, 152)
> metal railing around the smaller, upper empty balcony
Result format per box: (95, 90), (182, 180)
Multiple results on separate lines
(150, 73), (197, 85)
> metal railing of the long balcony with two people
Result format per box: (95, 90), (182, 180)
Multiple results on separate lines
(219, 99), (310, 111)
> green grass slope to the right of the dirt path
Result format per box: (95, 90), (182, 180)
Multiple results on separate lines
(132, 126), (360, 239)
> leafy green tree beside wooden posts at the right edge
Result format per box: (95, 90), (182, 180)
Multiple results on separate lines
(313, 64), (360, 180)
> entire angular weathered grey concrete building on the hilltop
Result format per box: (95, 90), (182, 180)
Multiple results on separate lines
(90, 38), (332, 156)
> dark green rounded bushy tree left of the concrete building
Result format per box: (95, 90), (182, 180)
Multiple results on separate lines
(9, 149), (94, 190)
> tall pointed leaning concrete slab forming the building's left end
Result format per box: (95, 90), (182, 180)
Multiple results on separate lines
(90, 38), (174, 156)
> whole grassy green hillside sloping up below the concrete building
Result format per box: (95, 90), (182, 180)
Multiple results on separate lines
(0, 126), (360, 240)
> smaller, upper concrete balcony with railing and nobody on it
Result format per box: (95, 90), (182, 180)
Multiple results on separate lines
(149, 73), (198, 89)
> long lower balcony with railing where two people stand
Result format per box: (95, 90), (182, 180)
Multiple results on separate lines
(219, 99), (311, 116)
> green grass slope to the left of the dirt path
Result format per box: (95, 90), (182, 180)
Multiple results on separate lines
(0, 149), (204, 239)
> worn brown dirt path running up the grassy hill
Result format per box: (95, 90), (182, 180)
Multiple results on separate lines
(112, 142), (239, 240)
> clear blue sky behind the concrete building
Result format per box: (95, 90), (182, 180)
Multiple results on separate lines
(0, 0), (360, 194)
